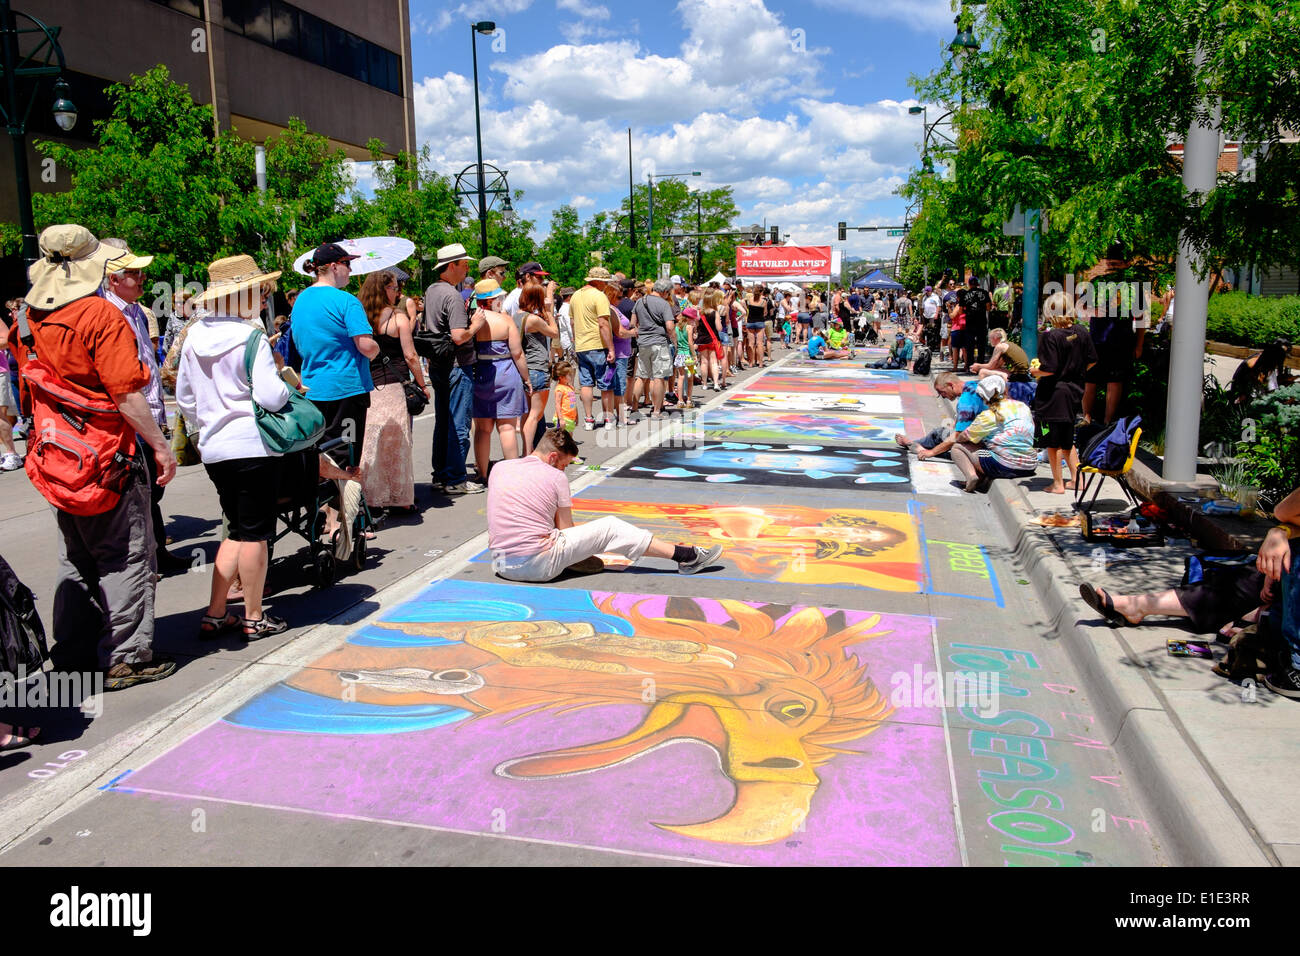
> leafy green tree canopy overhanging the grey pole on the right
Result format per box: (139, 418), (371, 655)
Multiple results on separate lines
(906, 0), (1300, 282)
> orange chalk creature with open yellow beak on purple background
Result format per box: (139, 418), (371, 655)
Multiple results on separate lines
(289, 598), (891, 844)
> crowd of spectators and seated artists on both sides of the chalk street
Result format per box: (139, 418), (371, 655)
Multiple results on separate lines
(0, 226), (1300, 759)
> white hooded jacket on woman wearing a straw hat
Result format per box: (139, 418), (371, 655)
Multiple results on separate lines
(176, 315), (289, 463)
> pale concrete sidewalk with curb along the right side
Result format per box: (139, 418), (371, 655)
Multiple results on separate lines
(988, 447), (1300, 866)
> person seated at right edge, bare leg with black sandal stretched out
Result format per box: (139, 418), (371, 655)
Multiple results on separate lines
(1079, 488), (1300, 647)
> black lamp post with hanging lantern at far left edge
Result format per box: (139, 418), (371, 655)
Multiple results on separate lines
(0, 0), (77, 265)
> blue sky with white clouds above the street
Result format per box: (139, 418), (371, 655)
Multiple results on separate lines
(411, 0), (954, 258)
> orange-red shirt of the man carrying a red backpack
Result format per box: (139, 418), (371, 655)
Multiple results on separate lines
(9, 295), (150, 398)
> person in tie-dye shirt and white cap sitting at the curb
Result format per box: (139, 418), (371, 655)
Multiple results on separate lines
(953, 375), (1039, 492)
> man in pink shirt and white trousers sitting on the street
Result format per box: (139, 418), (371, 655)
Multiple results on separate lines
(488, 428), (723, 581)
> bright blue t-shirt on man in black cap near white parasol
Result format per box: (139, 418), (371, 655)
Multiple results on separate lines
(290, 285), (374, 402)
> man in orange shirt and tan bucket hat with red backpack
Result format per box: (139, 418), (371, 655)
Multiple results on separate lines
(9, 225), (176, 691)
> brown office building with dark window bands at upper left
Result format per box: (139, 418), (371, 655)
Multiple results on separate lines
(0, 0), (415, 230)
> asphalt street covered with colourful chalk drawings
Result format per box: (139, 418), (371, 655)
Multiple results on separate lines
(0, 351), (1167, 866)
